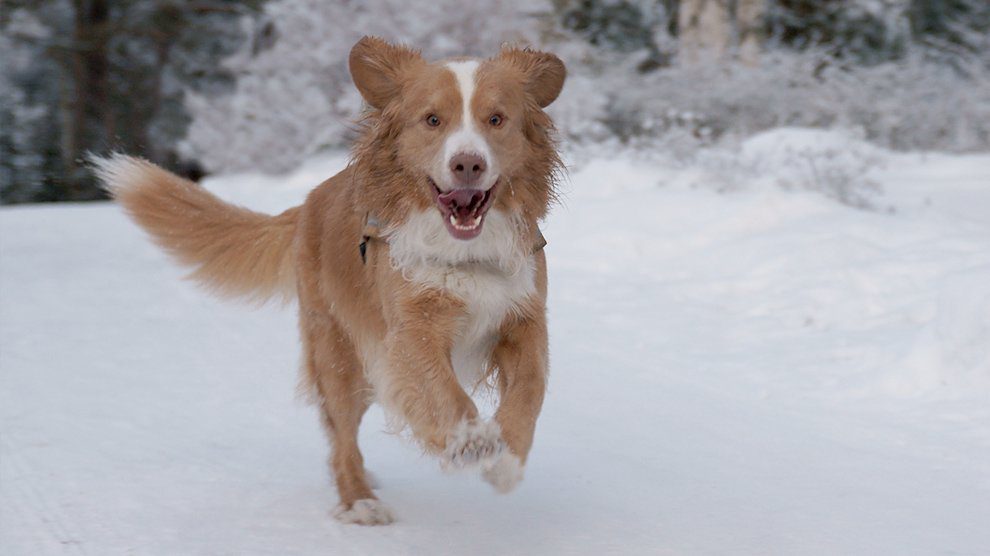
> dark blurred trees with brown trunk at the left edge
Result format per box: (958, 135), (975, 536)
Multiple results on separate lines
(0, 0), (261, 202)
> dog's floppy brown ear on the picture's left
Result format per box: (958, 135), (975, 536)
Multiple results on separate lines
(348, 36), (424, 109)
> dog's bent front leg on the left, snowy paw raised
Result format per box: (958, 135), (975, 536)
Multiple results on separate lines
(376, 290), (504, 468)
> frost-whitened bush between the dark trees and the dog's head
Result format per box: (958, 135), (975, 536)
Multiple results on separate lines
(183, 0), (547, 171)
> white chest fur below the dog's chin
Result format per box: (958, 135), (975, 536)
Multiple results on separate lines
(387, 210), (536, 389)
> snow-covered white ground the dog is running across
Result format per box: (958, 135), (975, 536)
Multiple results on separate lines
(0, 131), (990, 556)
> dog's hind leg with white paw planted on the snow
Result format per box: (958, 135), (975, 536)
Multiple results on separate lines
(301, 313), (393, 525)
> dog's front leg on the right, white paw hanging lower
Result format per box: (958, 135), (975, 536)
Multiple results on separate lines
(483, 307), (547, 493)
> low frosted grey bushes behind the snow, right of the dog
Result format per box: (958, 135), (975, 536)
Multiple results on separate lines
(555, 45), (990, 157)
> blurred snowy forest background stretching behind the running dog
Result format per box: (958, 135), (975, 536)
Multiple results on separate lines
(0, 0), (990, 204)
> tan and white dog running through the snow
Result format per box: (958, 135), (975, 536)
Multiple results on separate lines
(93, 37), (566, 525)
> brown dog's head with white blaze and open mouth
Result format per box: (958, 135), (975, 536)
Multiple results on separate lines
(350, 37), (566, 240)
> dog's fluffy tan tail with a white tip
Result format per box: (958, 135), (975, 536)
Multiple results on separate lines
(90, 154), (299, 301)
